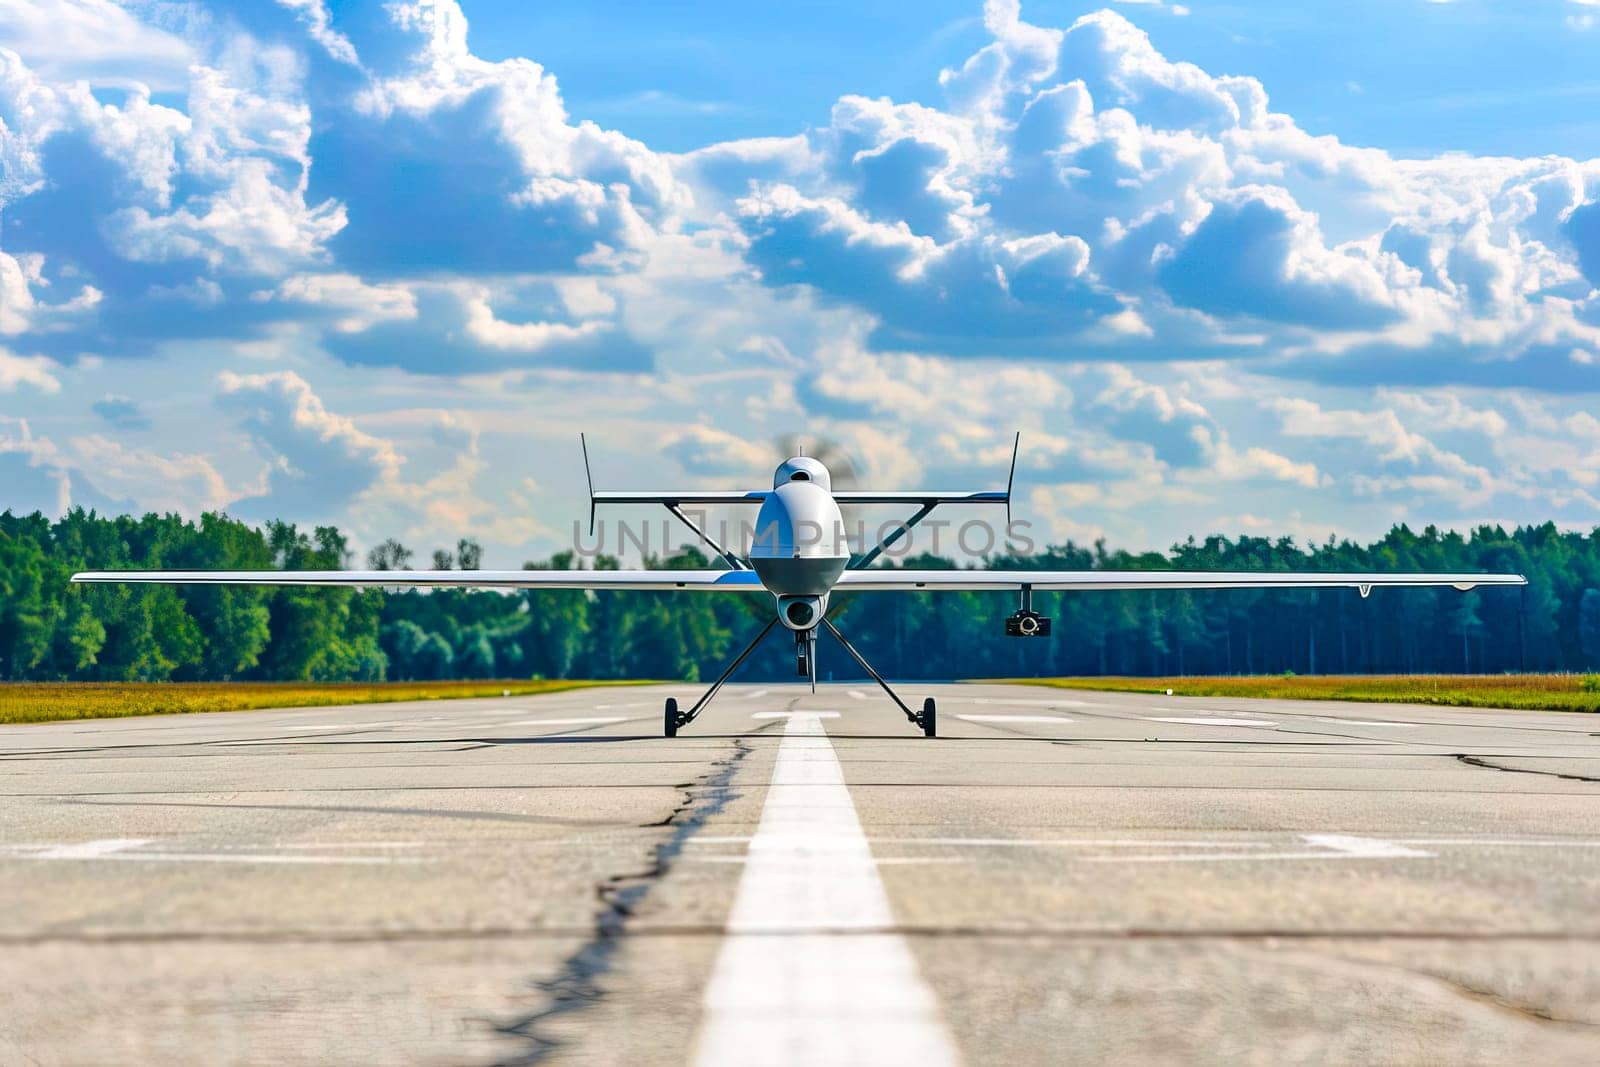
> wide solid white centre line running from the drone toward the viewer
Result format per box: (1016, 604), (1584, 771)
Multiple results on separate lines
(694, 713), (958, 1067)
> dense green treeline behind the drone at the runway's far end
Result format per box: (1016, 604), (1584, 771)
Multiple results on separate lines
(0, 510), (1600, 681)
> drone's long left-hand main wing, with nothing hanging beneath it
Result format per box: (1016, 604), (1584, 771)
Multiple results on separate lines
(72, 571), (762, 592)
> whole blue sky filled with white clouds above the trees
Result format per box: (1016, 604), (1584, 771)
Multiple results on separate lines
(0, 0), (1600, 565)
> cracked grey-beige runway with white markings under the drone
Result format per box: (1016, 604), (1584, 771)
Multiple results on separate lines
(0, 683), (1600, 1067)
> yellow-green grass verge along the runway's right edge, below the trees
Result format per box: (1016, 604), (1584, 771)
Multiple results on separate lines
(1003, 675), (1600, 712)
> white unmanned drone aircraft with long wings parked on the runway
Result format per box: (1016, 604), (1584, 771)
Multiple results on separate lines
(72, 435), (1526, 737)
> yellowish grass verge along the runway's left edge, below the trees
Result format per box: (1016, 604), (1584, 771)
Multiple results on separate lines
(0, 678), (648, 723)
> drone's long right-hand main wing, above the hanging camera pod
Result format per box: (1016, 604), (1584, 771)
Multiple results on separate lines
(835, 568), (1528, 597)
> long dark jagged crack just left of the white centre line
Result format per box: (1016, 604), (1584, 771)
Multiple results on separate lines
(493, 739), (752, 1067)
